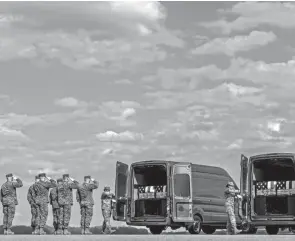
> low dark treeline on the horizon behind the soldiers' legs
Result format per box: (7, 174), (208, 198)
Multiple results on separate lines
(0, 225), (149, 235)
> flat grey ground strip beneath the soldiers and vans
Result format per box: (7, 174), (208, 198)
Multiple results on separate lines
(0, 235), (294, 241)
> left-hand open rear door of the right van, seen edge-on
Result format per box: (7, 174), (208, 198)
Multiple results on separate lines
(239, 154), (251, 226)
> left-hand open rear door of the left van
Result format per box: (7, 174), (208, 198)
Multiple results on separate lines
(113, 161), (129, 221)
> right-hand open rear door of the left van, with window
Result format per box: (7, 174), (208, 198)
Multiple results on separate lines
(172, 163), (194, 222)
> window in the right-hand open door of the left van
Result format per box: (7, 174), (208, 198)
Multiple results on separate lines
(174, 173), (191, 197)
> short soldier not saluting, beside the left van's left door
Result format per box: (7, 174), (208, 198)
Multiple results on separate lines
(101, 186), (115, 234)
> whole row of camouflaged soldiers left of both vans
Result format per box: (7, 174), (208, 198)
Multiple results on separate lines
(0, 173), (115, 235)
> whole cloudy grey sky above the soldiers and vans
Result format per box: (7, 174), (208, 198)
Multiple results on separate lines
(0, 2), (295, 226)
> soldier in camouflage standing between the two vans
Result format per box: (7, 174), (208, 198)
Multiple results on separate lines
(224, 182), (239, 235)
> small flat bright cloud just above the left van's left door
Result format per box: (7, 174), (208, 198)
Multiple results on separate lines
(96, 131), (143, 142)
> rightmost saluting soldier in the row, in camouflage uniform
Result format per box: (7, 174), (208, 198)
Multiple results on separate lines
(76, 176), (98, 234)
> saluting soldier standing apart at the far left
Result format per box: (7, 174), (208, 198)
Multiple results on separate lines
(0, 173), (23, 235)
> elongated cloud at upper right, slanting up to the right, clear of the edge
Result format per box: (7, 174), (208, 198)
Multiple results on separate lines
(192, 31), (277, 56)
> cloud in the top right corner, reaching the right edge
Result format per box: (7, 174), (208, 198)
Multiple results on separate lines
(200, 2), (295, 34)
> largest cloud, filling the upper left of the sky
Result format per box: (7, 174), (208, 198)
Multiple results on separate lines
(0, 2), (184, 73)
